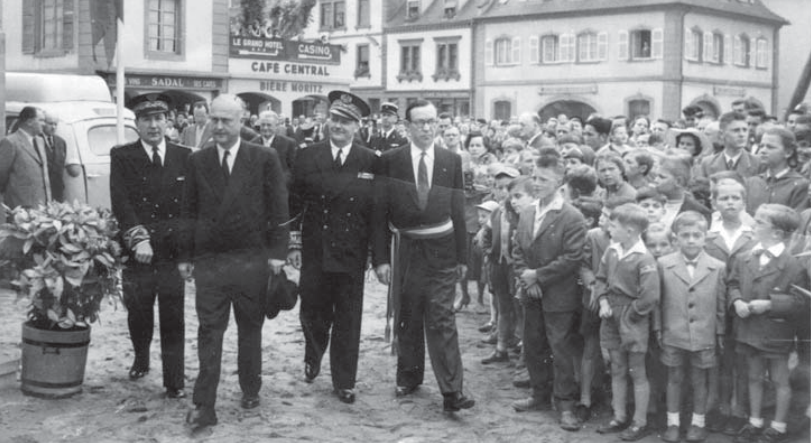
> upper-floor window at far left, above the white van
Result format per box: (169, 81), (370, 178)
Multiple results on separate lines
(22, 0), (75, 57)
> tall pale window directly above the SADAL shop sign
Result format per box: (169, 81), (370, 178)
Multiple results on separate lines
(146, 0), (183, 58)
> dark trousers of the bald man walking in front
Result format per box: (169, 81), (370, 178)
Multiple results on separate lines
(193, 254), (269, 407)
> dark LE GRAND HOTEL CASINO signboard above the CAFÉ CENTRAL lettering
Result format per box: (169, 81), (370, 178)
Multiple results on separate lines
(230, 35), (341, 65)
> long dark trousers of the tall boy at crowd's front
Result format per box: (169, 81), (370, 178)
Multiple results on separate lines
(524, 300), (577, 411)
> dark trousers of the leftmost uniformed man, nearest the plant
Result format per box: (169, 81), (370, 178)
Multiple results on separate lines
(123, 262), (185, 389)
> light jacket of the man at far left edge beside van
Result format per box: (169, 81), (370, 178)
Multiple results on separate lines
(0, 129), (51, 209)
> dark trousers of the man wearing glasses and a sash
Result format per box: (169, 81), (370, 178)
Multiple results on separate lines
(396, 260), (463, 394)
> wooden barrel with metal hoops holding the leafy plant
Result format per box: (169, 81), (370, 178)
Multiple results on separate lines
(20, 322), (90, 398)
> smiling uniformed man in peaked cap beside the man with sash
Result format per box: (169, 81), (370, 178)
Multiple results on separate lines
(288, 91), (385, 403)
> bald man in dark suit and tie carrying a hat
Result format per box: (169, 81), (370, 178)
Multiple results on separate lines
(178, 94), (289, 429)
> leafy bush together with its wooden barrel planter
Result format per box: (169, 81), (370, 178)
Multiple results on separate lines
(0, 202), (123, 397)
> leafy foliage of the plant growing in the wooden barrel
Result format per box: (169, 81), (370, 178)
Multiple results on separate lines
(0, 202), (125, 329)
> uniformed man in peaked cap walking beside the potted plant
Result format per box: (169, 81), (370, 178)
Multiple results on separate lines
(110, 94), (191, 398)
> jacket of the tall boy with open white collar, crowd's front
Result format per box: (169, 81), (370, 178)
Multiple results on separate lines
(513, 199), (586, 312)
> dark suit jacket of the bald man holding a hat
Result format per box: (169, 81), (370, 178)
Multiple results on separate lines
(180, 140), (289, 261)
